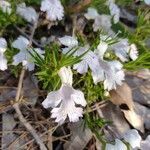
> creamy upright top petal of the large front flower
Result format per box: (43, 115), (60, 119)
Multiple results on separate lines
(58, 67), (73, 86)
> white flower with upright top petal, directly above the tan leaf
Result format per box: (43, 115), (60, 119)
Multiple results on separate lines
(92, 42), (125, 91)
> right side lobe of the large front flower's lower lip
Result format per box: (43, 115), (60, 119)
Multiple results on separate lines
(71, 90), (87, 107)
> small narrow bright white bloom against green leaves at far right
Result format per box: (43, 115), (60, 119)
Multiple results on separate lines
(129, 44), (139, 61)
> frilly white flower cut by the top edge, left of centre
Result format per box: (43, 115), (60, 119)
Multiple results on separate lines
(41, 0), (64, 21)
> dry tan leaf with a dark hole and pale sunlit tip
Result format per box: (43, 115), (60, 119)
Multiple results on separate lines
(110, 83), (144, 132)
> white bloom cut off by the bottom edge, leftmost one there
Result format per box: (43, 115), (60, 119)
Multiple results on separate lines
(105, 139), (127, 150)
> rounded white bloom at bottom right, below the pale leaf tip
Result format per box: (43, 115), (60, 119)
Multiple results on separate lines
(123, 129), (141, 149)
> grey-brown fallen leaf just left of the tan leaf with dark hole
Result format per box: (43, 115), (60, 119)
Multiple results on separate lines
(98, 102), (130, 141)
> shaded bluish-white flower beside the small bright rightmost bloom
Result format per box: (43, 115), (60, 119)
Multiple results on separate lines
(111, 39), (130, 62)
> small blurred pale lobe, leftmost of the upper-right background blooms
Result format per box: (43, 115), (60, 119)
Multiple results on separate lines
(84, 8), (99, 20)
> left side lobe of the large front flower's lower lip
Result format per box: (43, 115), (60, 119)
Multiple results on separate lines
(42, 90), (62, 108)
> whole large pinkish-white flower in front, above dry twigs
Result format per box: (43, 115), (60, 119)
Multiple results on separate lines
(42, 67), (86, 124)
